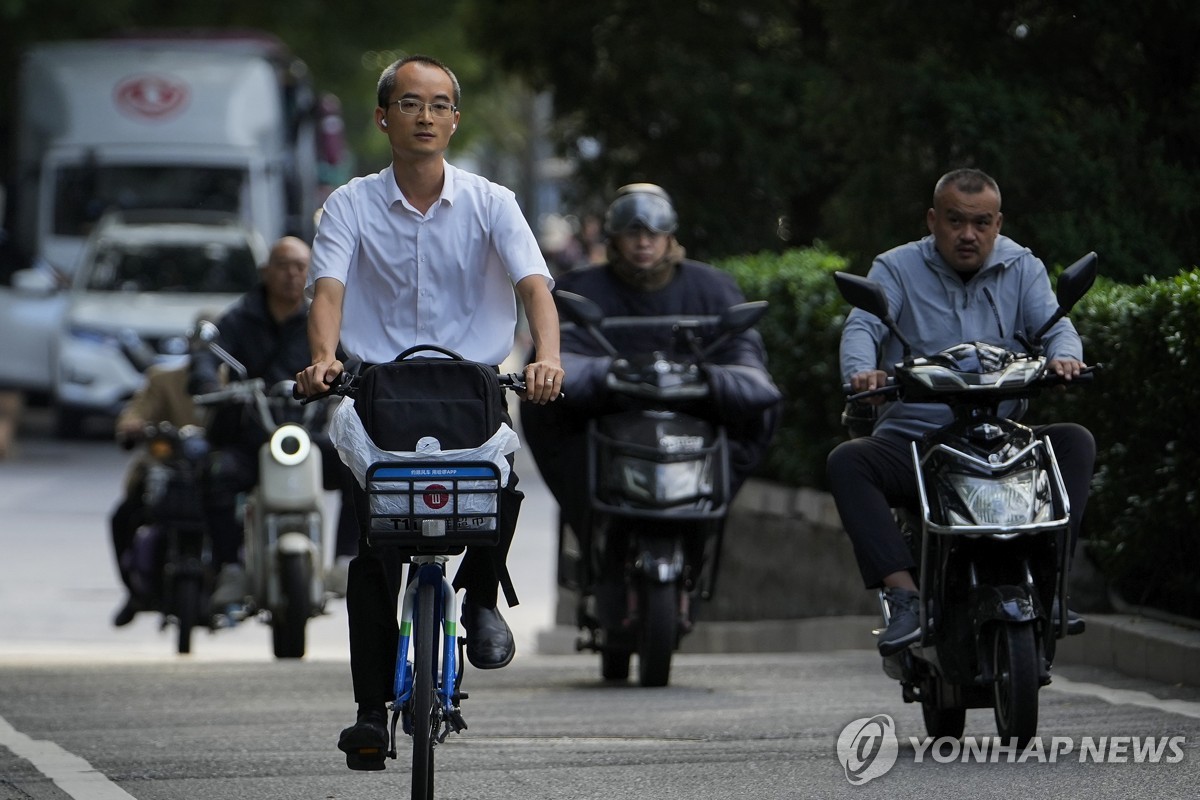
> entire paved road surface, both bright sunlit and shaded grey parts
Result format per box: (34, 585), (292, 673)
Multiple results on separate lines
(0, 410), (1200, 800)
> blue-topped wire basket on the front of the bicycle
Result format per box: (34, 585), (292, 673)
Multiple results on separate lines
(366, 461), (500, 553)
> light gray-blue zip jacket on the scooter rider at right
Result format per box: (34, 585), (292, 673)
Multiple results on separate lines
(841, 235), (1084, 439)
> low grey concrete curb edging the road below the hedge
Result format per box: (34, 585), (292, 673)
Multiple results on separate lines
(538, 614), (1200, 686)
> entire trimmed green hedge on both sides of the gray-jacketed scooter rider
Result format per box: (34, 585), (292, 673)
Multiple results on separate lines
(720, 246), (1200, 618)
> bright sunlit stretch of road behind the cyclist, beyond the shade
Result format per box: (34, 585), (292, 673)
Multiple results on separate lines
(0, 409), (556, 661)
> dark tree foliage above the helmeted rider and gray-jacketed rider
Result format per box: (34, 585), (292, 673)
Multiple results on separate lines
(469, 0), (1200, 281)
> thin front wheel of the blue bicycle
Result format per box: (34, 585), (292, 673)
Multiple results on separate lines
(413, 583), (442, 800)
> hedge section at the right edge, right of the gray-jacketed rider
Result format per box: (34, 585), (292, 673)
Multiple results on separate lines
(1038, 270), (1200, 618)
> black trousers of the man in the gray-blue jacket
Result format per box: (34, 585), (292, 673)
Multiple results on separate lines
(827, 422), (1096, 589)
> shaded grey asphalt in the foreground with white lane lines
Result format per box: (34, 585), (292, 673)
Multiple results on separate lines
(0, 651), (1200, 800)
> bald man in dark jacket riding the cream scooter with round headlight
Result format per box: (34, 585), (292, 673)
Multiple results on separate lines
(188, 236), (358, 608)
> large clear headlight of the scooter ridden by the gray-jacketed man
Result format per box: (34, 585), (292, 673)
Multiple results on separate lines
(947, 469), (1052, 525)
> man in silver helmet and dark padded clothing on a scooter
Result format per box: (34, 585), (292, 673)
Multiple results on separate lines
(521, 184), (782, 556)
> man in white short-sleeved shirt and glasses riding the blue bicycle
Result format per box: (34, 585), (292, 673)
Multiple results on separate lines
(296, 55), (563, 760)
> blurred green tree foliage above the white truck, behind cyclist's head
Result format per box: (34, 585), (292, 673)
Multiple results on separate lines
(0, 0), (528, 203)
